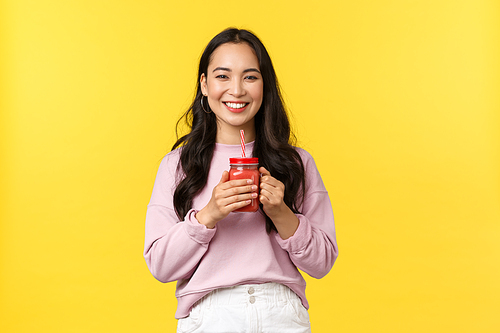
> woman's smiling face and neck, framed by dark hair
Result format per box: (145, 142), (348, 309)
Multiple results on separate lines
(200, 43), (264, 139)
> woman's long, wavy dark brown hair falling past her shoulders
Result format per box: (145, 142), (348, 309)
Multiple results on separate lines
(172, 28), (305, 233)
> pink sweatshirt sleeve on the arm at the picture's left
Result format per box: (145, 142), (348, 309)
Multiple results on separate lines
(144, 152), (216, 282)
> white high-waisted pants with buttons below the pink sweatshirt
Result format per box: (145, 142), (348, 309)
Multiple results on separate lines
(177, 283), (311, 333)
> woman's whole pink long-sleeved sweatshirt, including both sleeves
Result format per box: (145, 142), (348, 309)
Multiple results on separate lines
(144, 142), (338, 319)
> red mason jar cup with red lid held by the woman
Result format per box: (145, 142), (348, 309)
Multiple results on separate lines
(229, 157), (260, 212)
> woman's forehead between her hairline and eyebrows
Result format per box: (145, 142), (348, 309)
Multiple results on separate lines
(208, 43), (260, 71)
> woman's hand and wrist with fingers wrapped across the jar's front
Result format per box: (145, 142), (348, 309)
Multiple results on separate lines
(195, 171), (258, 229)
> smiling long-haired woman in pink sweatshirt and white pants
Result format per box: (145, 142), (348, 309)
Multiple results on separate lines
(144, 29), (338, 333)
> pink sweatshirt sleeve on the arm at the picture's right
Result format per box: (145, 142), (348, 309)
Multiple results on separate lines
(275, 150), (338, 279)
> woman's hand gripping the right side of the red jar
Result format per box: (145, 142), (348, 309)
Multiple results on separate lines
(259, 167), (288, 220)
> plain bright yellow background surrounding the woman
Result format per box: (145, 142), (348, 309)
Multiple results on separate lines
(0, 0), (500, 333)
